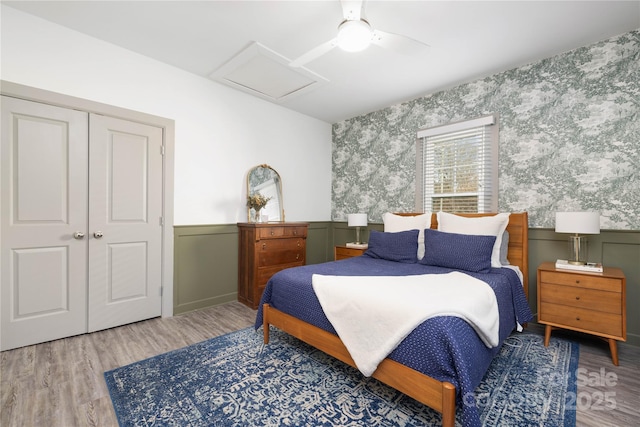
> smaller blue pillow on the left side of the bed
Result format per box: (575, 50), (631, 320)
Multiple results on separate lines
(364, 230), (419, 264)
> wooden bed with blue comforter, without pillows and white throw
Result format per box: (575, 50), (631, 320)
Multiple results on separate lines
(256, 212), (532, 427)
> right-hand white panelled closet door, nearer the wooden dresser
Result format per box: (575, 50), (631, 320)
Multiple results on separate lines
(88, 114), (163, 332)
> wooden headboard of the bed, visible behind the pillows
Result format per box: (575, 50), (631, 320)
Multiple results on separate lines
(395, 212), (529, 299)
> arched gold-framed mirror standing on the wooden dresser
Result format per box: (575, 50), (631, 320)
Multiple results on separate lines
(247, 164), (284, 222)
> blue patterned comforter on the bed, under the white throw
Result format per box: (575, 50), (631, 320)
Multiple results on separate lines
(255, 255), (533, 427)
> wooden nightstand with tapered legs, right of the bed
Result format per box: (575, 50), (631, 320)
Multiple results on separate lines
(538, 262), (627, 366)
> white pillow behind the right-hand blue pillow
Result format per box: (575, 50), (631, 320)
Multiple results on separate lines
(438, 212), (511, 268)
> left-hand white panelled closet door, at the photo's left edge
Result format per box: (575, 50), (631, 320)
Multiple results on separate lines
(0, 96), (88, 350)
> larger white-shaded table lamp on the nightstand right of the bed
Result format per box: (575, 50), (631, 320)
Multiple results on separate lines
(556, 212), (600, 265)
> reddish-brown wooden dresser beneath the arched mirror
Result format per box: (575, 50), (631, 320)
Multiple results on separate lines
(238, 222), (308, 309)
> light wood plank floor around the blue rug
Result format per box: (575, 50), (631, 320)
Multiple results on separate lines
(0, 302), (640, 427)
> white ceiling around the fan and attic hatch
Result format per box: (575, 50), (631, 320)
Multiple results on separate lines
(2, 0), (640, 123)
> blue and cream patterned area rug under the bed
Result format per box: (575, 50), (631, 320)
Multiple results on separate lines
(104, 328), (579, 427)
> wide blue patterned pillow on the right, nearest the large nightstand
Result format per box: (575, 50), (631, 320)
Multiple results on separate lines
(420, 228), (496, 273)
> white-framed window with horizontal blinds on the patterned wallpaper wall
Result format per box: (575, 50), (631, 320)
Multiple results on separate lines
(416, 116), (498, 213)
